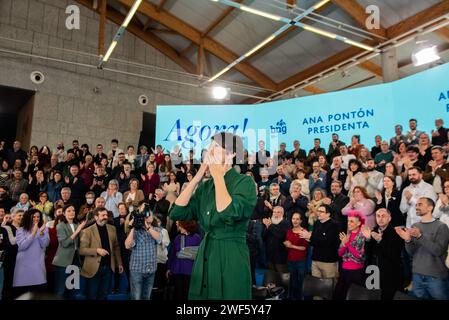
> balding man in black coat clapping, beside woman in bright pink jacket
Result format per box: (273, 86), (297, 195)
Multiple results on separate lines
(362, 208), (404, 300)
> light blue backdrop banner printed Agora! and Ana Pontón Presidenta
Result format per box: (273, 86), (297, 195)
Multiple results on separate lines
(156, 64), (449, 154)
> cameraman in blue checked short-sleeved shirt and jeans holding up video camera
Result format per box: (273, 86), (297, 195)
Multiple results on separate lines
(125, 201), (162, 300)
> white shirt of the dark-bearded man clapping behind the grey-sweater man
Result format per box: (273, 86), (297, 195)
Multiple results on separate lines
(399, 180), (438, 228)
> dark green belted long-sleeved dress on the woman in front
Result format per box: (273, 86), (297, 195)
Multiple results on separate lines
(170, 168), (257, 300)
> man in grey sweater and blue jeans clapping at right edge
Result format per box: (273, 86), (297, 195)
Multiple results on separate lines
(396, 198), (449, 300)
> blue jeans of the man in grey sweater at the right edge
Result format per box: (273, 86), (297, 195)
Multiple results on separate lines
(412, 273), (449, 300)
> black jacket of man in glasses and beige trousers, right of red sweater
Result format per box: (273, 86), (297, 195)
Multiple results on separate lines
(310, 219), (340, 262)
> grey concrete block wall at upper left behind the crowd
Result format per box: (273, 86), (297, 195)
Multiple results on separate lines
(0, 0), (210, 148)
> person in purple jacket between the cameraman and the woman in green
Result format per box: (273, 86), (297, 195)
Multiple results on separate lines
(167, 221), (201, 301)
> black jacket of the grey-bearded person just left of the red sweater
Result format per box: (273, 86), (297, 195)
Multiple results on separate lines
(263, 219), (290, 264)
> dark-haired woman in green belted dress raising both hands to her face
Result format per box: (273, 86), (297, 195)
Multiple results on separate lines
(170, 133), (257, 300)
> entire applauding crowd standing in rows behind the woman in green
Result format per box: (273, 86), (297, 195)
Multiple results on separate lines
(0, 119), (449, 300)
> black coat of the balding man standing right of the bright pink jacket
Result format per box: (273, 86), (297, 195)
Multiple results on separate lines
(365, 224), (404, 300)
